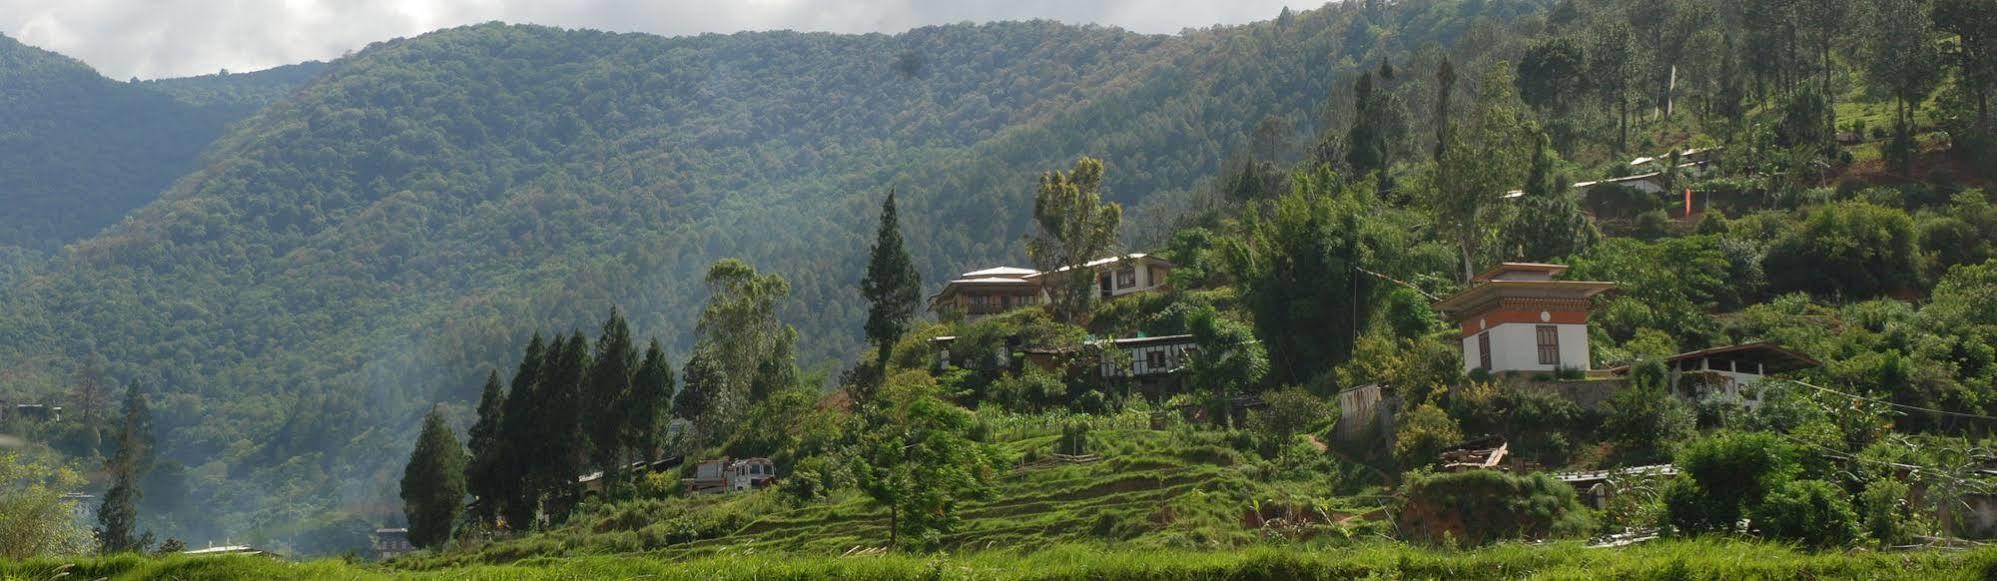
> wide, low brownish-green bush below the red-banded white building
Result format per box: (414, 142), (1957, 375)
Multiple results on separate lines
(1400, 469), (1588, 545)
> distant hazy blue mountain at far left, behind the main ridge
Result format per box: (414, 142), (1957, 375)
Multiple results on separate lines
(0, 36), (320, 255)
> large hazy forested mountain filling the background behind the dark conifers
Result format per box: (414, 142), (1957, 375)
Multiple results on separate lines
(0, 0), (1546, 539)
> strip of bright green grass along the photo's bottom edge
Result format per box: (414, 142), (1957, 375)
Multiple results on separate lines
(0, 541), (1997, 581)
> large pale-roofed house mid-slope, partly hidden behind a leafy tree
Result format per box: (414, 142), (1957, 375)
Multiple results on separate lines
(929, 254), (1172, 319)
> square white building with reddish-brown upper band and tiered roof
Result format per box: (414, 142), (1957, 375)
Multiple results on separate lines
(1436, 262), (1616, 371)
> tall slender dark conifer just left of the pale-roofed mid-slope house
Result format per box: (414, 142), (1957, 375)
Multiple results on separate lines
(855, 190), (923, 395)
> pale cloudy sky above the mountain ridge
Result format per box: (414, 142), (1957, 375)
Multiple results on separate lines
(0, 0), (1302, 80)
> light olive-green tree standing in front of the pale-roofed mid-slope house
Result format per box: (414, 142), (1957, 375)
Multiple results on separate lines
(1026, 156), (1122, 323)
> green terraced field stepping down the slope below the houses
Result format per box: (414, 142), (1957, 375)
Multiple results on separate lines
(401, 427), (1382, 569)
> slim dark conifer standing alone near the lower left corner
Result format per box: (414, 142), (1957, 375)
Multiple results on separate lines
(96, 381), (152, 553)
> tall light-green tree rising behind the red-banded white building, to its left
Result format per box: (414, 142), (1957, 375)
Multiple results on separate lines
(1430, 64), (1538, 282)
